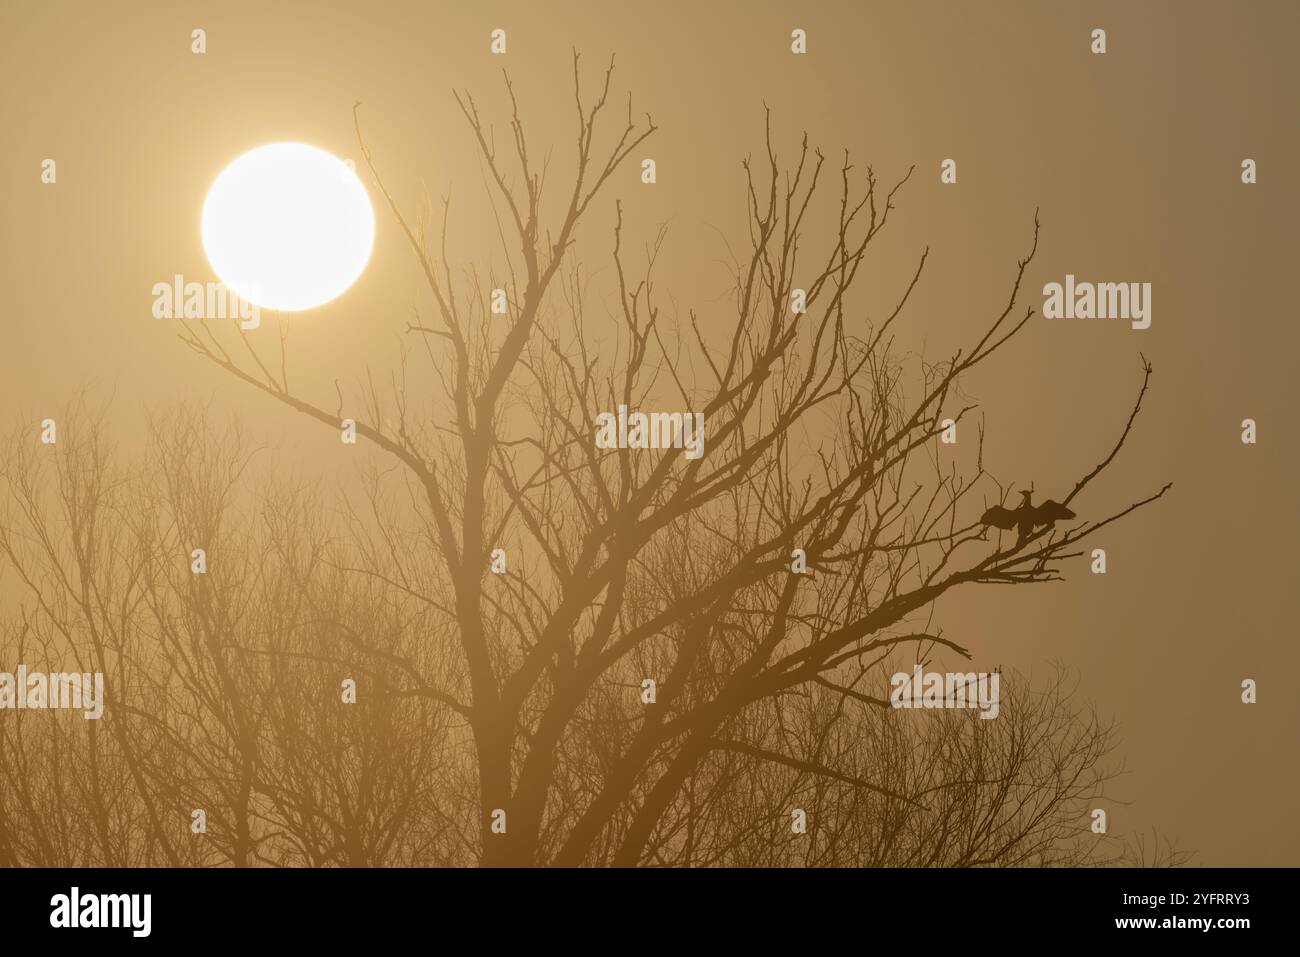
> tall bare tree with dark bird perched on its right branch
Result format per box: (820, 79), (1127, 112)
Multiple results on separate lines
(175, 55), (1167, 865)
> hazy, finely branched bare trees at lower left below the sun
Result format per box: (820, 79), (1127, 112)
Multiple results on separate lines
(0, 406), (460, 866)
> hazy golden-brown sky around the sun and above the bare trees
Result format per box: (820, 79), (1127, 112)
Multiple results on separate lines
(0, 0), (1300, 865)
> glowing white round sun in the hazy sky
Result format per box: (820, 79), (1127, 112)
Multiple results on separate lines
(203, 143), (374, 312)
